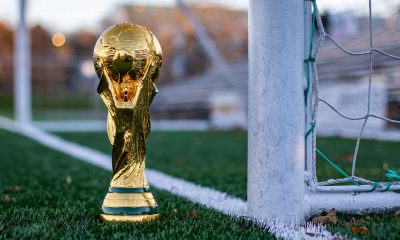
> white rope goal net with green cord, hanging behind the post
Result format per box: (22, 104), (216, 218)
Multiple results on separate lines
(305, 0), (400, 193)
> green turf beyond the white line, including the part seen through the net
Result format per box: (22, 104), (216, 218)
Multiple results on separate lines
(60, 132), (400, 239)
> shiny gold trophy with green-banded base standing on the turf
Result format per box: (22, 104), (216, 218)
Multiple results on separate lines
(93, 23), (162, 222)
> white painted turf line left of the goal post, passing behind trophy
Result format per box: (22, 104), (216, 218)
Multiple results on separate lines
(0, 117), (246, 216)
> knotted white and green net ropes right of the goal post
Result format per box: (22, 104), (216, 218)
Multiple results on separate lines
(305, 0), (400, 192)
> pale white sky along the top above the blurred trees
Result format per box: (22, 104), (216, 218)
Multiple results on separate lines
(0, 0), (400, 32)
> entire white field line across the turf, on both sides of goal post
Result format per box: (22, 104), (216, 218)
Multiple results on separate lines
(0, 116), (334, 239)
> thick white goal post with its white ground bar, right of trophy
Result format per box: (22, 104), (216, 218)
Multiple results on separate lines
(247, 0), (400, 222)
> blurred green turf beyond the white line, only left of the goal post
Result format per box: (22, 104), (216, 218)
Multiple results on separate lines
(60, 132), (247, 199)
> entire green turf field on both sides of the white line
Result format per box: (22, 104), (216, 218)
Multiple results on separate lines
(0, 131), (400, 239)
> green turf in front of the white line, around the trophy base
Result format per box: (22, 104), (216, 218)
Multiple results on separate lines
(0, 130), (273, 239)
